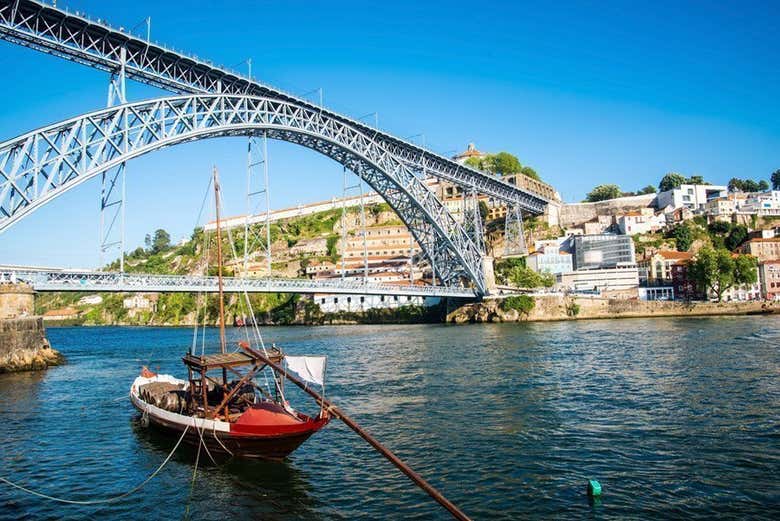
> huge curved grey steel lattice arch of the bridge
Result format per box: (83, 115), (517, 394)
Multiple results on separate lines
(0, 95), (486, 294)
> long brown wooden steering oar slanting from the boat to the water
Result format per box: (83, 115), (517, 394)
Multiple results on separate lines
(239, 342), (471, 521)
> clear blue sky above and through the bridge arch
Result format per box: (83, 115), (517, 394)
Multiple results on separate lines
(0, 0), (780, 267)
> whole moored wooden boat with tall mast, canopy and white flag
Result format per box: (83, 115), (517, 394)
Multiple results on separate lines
(130, 168), (330, 460)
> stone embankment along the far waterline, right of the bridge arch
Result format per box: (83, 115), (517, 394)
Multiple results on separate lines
(446, 295), (780, 324)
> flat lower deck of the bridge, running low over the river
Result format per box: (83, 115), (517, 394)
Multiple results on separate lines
(0, 269), (477, 298)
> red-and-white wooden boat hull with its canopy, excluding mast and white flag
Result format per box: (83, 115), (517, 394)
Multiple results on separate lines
(130, 350), (329, 460)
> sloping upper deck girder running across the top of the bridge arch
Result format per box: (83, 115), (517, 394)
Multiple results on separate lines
(0, 0), (553, 215)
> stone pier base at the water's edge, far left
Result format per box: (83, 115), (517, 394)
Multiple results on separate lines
(0, 317), (64, 373)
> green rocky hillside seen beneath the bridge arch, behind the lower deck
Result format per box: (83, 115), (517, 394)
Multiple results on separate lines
(36, 204), (413, 326)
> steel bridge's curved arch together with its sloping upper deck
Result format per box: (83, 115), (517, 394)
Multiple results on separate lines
(0, 0), (554, 296)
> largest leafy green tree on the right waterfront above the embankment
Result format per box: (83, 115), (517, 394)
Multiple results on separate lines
(689, 247), (757, 302)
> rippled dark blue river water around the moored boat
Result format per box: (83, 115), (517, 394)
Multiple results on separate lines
(0, 317), (780, 520)
